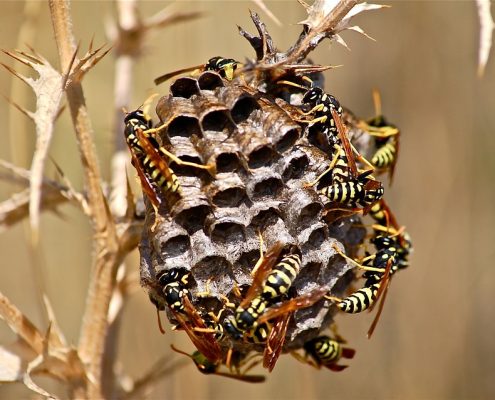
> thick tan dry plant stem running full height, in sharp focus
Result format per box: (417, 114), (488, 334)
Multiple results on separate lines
(49, 0), (121, 399)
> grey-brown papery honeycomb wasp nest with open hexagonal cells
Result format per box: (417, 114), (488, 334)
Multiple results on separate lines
(140, 71), (365, 352)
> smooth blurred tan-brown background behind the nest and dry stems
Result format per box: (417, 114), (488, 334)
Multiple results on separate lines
(0, 0), (495, 399)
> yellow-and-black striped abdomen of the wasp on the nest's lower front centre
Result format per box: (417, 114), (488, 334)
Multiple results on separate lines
(261, 254), (301, 300)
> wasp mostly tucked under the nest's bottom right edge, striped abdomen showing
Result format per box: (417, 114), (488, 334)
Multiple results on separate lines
(304, 335), (356, 372)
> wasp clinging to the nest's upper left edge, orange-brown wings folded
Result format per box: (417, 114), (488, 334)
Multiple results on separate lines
(124, 109), (213, 208)
